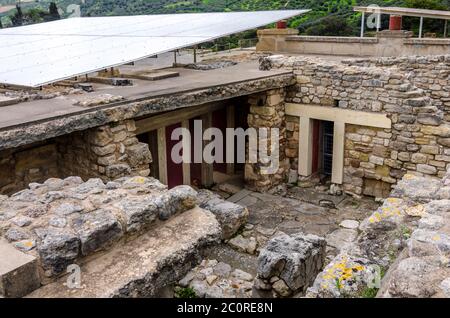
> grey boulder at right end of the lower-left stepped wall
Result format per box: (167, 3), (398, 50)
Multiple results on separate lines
(199, 191), (248, 240)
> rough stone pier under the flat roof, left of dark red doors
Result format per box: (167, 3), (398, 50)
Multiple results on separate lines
(58, 120), (152, 181)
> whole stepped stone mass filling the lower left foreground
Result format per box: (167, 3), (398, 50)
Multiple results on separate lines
(0, 177), (248, 297)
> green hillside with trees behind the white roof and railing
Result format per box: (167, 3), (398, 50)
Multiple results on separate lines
(0, 0), (450, 38)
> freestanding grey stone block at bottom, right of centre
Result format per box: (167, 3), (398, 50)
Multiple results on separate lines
(258, 233), (326, 292)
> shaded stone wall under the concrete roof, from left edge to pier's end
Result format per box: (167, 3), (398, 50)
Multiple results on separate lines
(0, 120), (152, 194)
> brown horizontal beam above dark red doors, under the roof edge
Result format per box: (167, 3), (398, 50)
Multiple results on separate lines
(136, 102), (226, 135)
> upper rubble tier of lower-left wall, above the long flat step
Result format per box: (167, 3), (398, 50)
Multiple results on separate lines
(0, 176), (200, 276)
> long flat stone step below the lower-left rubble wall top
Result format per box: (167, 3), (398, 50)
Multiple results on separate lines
(28, 208), (221, 298)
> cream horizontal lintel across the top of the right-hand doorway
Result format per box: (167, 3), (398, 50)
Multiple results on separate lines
(286, 103), (392, 129)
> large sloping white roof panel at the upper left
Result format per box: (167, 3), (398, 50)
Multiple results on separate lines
(0, 10), (309, 87)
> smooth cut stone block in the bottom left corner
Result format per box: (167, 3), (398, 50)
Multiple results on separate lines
(0, 239), (40, 297)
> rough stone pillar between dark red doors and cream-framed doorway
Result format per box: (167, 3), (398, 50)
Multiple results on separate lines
(245, 89), (289, 192)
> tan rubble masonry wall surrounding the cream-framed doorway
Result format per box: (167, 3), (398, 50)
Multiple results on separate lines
(265, 56), (450, 197)
